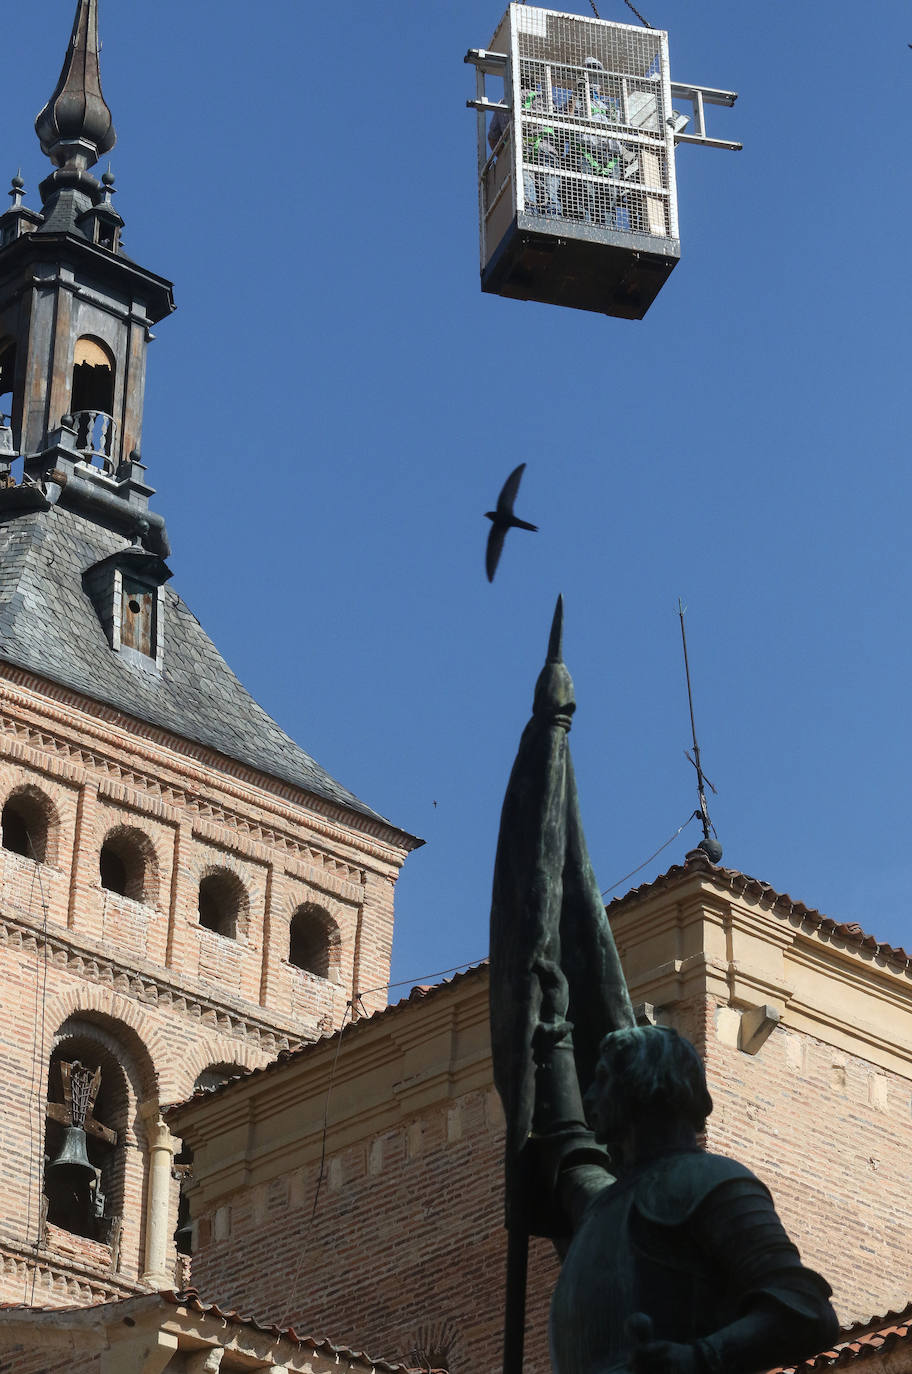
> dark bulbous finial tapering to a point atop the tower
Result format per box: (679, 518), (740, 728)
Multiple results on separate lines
(34, 0), (117, 173)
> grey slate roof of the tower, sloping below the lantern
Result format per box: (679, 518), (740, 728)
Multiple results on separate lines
(0, 506), (390, 824)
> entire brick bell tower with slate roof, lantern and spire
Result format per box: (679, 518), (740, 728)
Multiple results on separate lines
(0, 0), (420, 1313)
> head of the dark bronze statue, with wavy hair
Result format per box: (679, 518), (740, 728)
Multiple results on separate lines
(586, 1026), (713, 1153)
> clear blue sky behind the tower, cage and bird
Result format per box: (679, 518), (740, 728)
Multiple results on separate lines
(3, 0), (912, 980)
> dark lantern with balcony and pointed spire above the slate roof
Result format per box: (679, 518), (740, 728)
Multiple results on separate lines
(0, 0), (174, 541)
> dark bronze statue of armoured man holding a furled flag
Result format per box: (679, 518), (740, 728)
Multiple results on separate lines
(492, 602), (838, 1374)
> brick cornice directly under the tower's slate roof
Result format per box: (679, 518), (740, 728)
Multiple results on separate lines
(0, 676), (401, 882)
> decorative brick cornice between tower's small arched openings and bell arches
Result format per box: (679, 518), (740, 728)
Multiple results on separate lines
(0, 915), (302, 1054)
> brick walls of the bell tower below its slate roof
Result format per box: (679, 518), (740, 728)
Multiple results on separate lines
(0, 665), (405, 1305)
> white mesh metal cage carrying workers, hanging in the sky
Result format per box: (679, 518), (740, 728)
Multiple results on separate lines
(466, 4), (740, 320)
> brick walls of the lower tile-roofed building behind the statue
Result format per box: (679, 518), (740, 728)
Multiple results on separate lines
(177, 873), (912, 1374)
